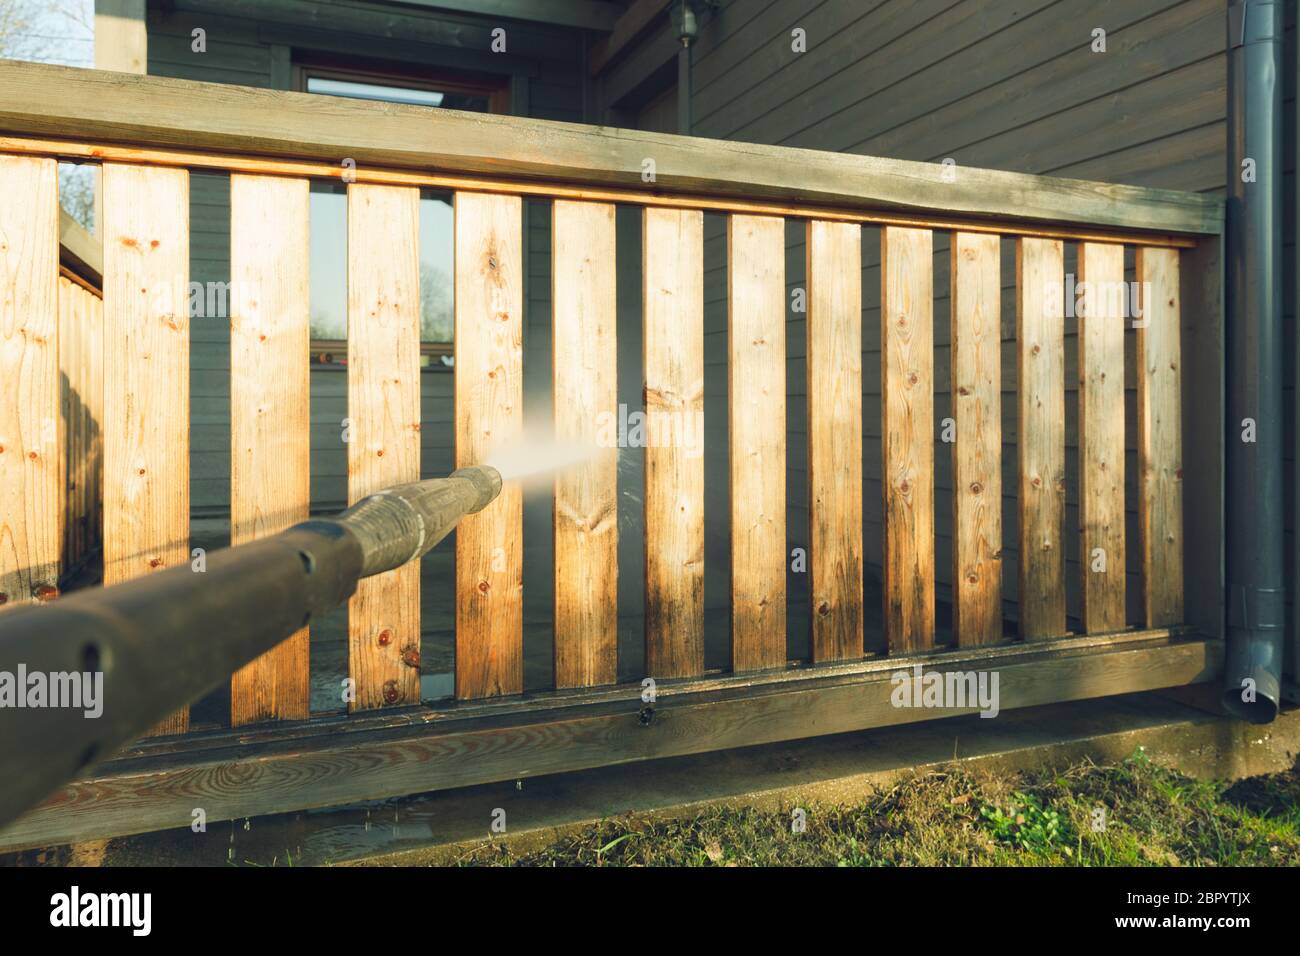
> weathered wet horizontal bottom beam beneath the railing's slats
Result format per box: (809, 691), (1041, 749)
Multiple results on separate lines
(0, 631), (1222, 851)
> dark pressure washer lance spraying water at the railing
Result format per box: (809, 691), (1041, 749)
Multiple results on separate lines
(0, 466), (501, 825)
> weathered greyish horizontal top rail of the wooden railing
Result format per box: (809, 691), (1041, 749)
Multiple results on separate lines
(0, 60), (1223, 243)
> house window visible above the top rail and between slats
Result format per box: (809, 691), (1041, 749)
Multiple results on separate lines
(296, 65), (508, 364)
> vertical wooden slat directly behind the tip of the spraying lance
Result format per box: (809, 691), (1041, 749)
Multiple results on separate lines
(455, 193), (524, 700)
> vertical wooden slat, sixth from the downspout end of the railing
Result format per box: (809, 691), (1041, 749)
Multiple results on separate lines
(806, 220), (865, 661)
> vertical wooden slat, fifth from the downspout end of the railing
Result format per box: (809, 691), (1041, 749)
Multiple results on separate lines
(880, 226), (935, 653)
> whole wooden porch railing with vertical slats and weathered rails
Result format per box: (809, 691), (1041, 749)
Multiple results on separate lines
(0, 64), (1222, 840)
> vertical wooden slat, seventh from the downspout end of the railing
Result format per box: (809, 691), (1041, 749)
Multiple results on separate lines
(727, 216), (785, 671)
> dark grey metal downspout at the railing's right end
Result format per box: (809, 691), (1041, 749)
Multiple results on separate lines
(1223, 0), (1286, 723)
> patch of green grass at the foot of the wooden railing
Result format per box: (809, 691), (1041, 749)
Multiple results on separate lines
(460, 750), (1300, 866)
